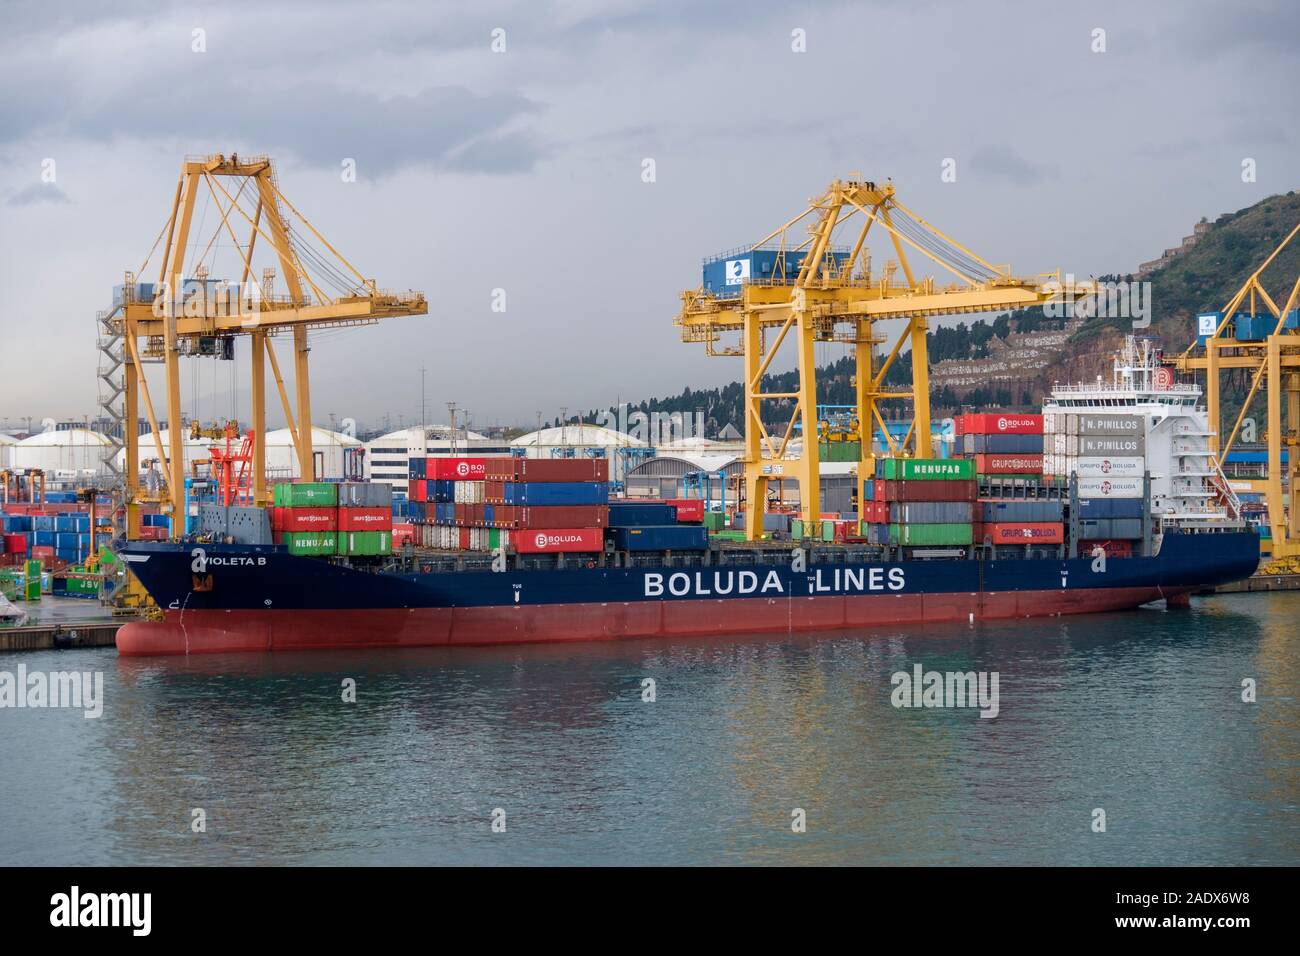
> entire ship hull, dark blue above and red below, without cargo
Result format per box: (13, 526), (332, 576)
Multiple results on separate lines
(118, 532), (1260, 654)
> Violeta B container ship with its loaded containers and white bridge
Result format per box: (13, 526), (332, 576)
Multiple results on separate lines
(117, 339), (1260, 656)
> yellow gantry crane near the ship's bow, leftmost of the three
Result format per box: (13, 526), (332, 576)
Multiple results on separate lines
(105, 153), (428, 538)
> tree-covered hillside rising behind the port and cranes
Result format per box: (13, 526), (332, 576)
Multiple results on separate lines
(575, 193), (1300, 434)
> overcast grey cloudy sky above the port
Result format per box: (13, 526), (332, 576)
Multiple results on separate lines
(0, 0), (1300, 434)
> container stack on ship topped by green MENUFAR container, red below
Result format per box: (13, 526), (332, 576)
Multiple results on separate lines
(862, 458), (976, 548)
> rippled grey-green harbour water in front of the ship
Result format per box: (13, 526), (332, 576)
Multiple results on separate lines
(0, 593), (1300, 865)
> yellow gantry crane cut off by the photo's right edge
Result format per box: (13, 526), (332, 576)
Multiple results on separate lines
(1177, 224), (1300, 561)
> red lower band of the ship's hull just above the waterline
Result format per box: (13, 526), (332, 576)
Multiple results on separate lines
(117, 588), (1190, 657)
